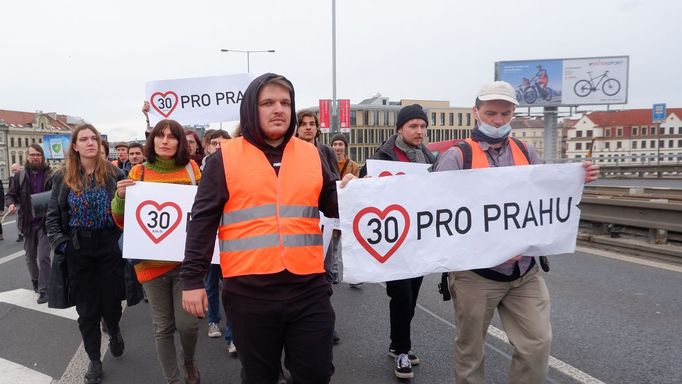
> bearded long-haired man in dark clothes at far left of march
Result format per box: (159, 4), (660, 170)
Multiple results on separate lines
(5, 144), (52, 304)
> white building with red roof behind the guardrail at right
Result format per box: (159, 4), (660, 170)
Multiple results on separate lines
(566, 108), (682, 165)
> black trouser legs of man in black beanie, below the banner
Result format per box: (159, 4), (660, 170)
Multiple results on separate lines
(386, 277), (424, 353)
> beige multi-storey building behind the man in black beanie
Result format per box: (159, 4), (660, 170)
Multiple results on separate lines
(310, 95), (474, 163)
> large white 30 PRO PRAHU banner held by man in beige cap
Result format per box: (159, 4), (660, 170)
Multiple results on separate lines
(338, 164), (585, 283)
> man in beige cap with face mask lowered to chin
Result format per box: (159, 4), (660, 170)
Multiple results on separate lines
(434, 81), (599, 384)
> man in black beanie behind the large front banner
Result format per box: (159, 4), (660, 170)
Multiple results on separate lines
(360, 104), (435, 379)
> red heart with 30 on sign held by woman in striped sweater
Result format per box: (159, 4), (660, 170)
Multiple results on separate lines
(135, 200), (182, 244)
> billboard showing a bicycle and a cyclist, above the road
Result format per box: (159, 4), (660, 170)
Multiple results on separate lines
(495, 56), (629, 107)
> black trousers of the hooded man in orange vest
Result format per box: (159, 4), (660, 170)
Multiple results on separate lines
(223, 286), (336, 384)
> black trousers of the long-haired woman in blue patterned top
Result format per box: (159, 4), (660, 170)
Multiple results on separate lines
(66, 230), (125, 360)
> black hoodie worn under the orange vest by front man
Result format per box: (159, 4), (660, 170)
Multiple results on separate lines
(182, 73), (339, 300)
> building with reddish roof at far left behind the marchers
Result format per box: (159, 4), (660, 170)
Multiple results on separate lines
(0, 109), (84, 181)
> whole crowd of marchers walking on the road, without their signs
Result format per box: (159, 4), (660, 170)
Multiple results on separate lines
(0, 73), (599, 384)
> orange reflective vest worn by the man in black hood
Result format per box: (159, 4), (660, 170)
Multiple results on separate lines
(218, 137), (324, 277)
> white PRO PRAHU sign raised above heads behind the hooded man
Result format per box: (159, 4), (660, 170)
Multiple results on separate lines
(146, 73), (254, 126)
